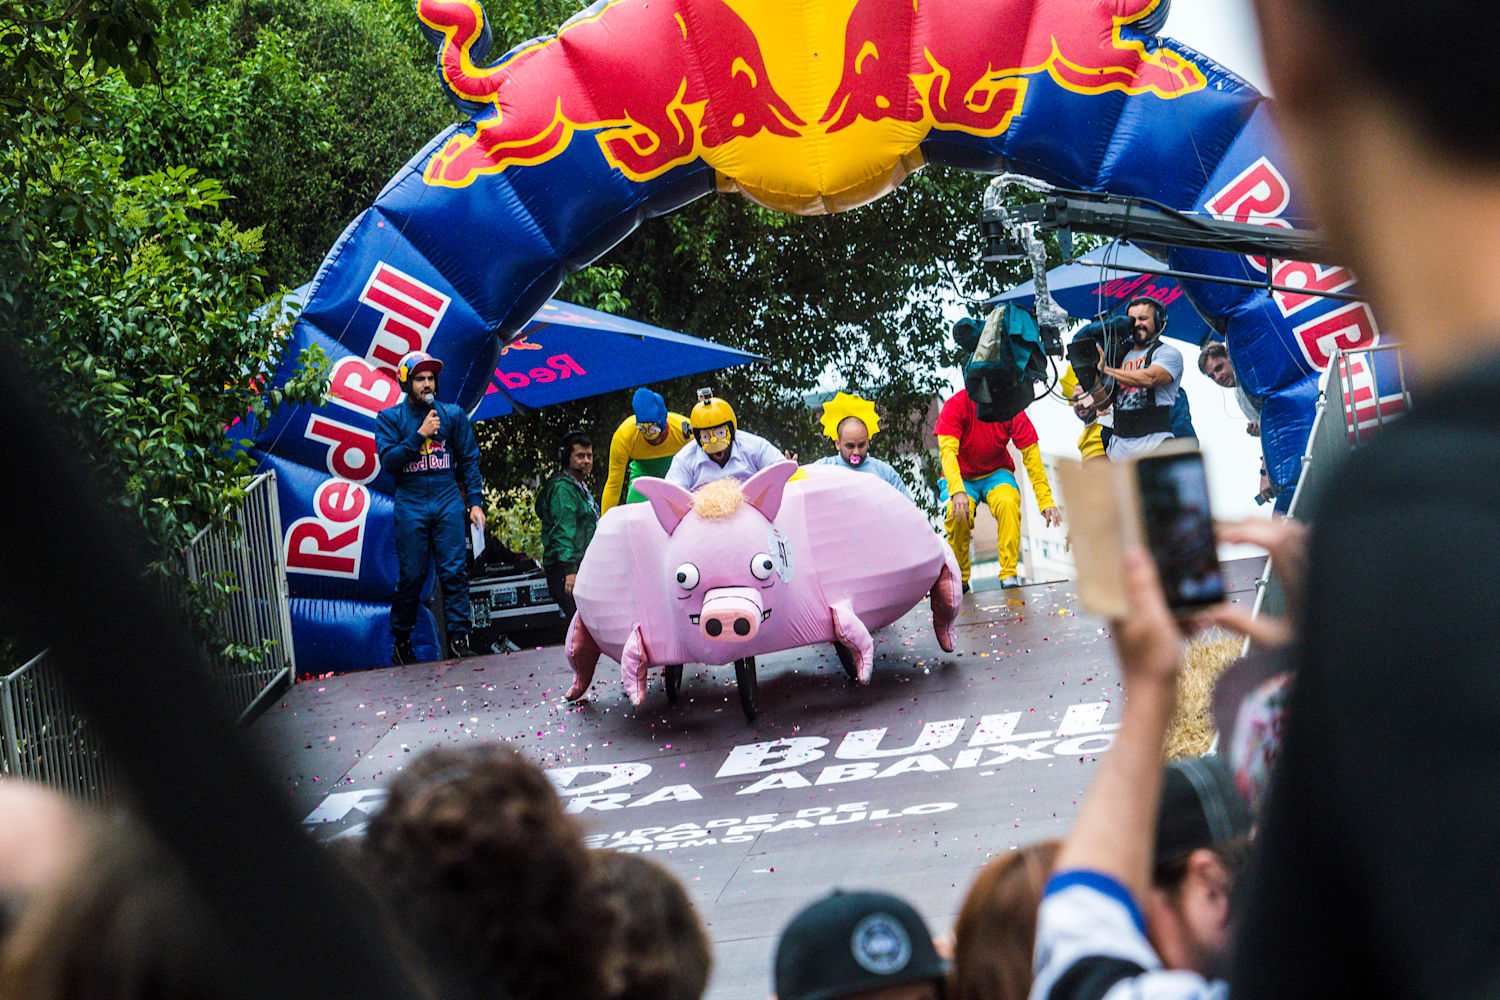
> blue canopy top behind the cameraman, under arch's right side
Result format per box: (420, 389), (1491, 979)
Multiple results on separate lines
(984, 243), (1217, 345)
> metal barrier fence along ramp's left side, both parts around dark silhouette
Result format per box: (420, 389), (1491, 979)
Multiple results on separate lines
(0, 472), (297, 802)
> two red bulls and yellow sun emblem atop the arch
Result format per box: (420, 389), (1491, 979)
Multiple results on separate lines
(419, 0), (1206, 211)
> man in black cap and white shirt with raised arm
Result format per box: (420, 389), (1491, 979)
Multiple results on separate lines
(1031, 549), (1250, 1000)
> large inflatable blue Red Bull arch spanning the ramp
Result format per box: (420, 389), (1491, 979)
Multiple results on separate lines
(254, 0), (1379, 672)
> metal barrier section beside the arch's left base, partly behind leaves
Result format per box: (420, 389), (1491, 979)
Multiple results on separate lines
(185, 471), (297, 721)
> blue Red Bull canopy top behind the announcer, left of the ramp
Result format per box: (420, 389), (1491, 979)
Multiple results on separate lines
(473, 298), (765, 420)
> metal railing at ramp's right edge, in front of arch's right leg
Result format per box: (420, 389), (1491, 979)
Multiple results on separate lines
(1245, 343), (1412, 641)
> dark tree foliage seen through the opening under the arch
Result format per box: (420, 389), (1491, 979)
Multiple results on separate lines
(479, 166), (1016, 512)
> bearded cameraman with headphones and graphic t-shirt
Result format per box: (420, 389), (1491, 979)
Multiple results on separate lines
(1097, 298), (1182, 462)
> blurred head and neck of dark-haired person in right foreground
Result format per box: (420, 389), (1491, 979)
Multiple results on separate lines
(1254, 0), (1500, 367)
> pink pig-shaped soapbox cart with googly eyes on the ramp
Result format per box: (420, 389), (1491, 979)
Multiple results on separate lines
(564, 462), (962, 720)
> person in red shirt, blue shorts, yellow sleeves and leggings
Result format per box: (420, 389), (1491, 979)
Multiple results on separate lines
(933, 390), (1062, 594)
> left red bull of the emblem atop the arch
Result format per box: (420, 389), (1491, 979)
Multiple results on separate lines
(417, 0), (804, 187)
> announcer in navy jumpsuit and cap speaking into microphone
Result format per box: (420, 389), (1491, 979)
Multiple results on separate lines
(375, 351), (485, 664)
